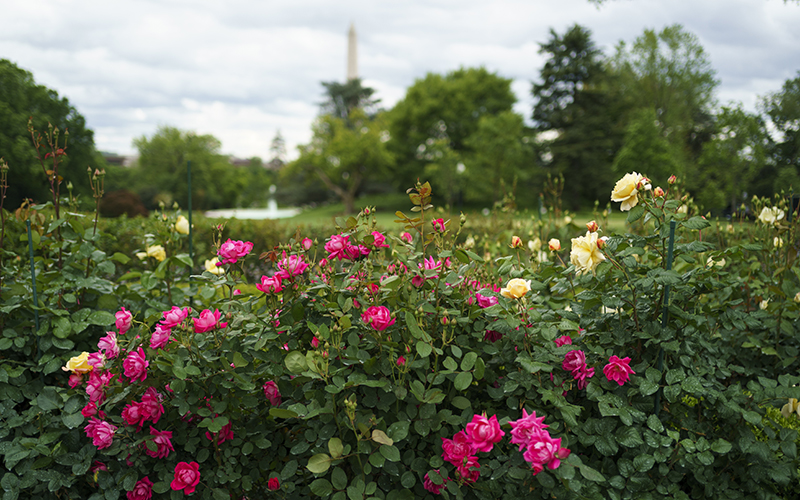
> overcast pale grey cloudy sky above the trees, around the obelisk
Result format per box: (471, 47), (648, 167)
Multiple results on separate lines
(0, 0), (800, 158)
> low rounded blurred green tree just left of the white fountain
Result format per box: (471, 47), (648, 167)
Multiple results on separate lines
(133, 126), (247, 210)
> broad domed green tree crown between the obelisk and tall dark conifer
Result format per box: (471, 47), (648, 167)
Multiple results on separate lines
(389, 68), (516, 185)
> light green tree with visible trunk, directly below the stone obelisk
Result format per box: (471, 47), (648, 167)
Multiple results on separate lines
(288, 108), (393, 213)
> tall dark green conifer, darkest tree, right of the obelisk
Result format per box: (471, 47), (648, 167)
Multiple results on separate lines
(532, 24), (624, 209)
